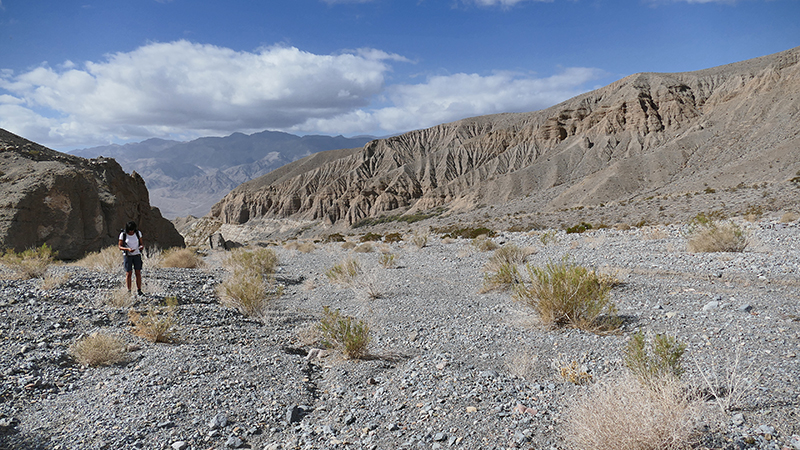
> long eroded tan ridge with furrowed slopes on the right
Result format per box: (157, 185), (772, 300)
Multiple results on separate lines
(211, 48), (800, 224)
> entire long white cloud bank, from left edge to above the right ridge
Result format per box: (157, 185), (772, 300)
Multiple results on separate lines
(0, 41), (601, 148)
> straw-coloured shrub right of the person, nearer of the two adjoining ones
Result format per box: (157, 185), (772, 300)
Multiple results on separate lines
(217, 270), (283, 318)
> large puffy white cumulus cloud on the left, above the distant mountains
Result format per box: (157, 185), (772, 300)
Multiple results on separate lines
(0, 41), (404, 144)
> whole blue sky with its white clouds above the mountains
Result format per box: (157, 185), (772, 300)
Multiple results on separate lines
(0, 0), (800, 150)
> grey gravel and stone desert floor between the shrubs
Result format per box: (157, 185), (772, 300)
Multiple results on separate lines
(0, 218), (800, 450)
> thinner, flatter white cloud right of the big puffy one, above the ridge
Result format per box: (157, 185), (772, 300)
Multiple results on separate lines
(294, 68), (605, 134)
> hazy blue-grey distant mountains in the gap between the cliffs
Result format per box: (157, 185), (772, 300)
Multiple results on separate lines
(70, 131), (375, 219)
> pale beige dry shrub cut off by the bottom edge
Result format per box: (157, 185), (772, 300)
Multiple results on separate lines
(566, 373), (698, 450)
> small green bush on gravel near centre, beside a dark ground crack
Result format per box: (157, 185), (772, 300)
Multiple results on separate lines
(319, 306), (370, 359)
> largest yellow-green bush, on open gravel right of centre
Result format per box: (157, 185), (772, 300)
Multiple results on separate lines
(515, 258), (619, 330)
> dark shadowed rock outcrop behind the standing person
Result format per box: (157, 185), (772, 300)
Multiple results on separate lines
(0, 130), (184, 259)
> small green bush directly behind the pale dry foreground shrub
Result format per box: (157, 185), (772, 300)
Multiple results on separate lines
(623, 330), (686, 384)
